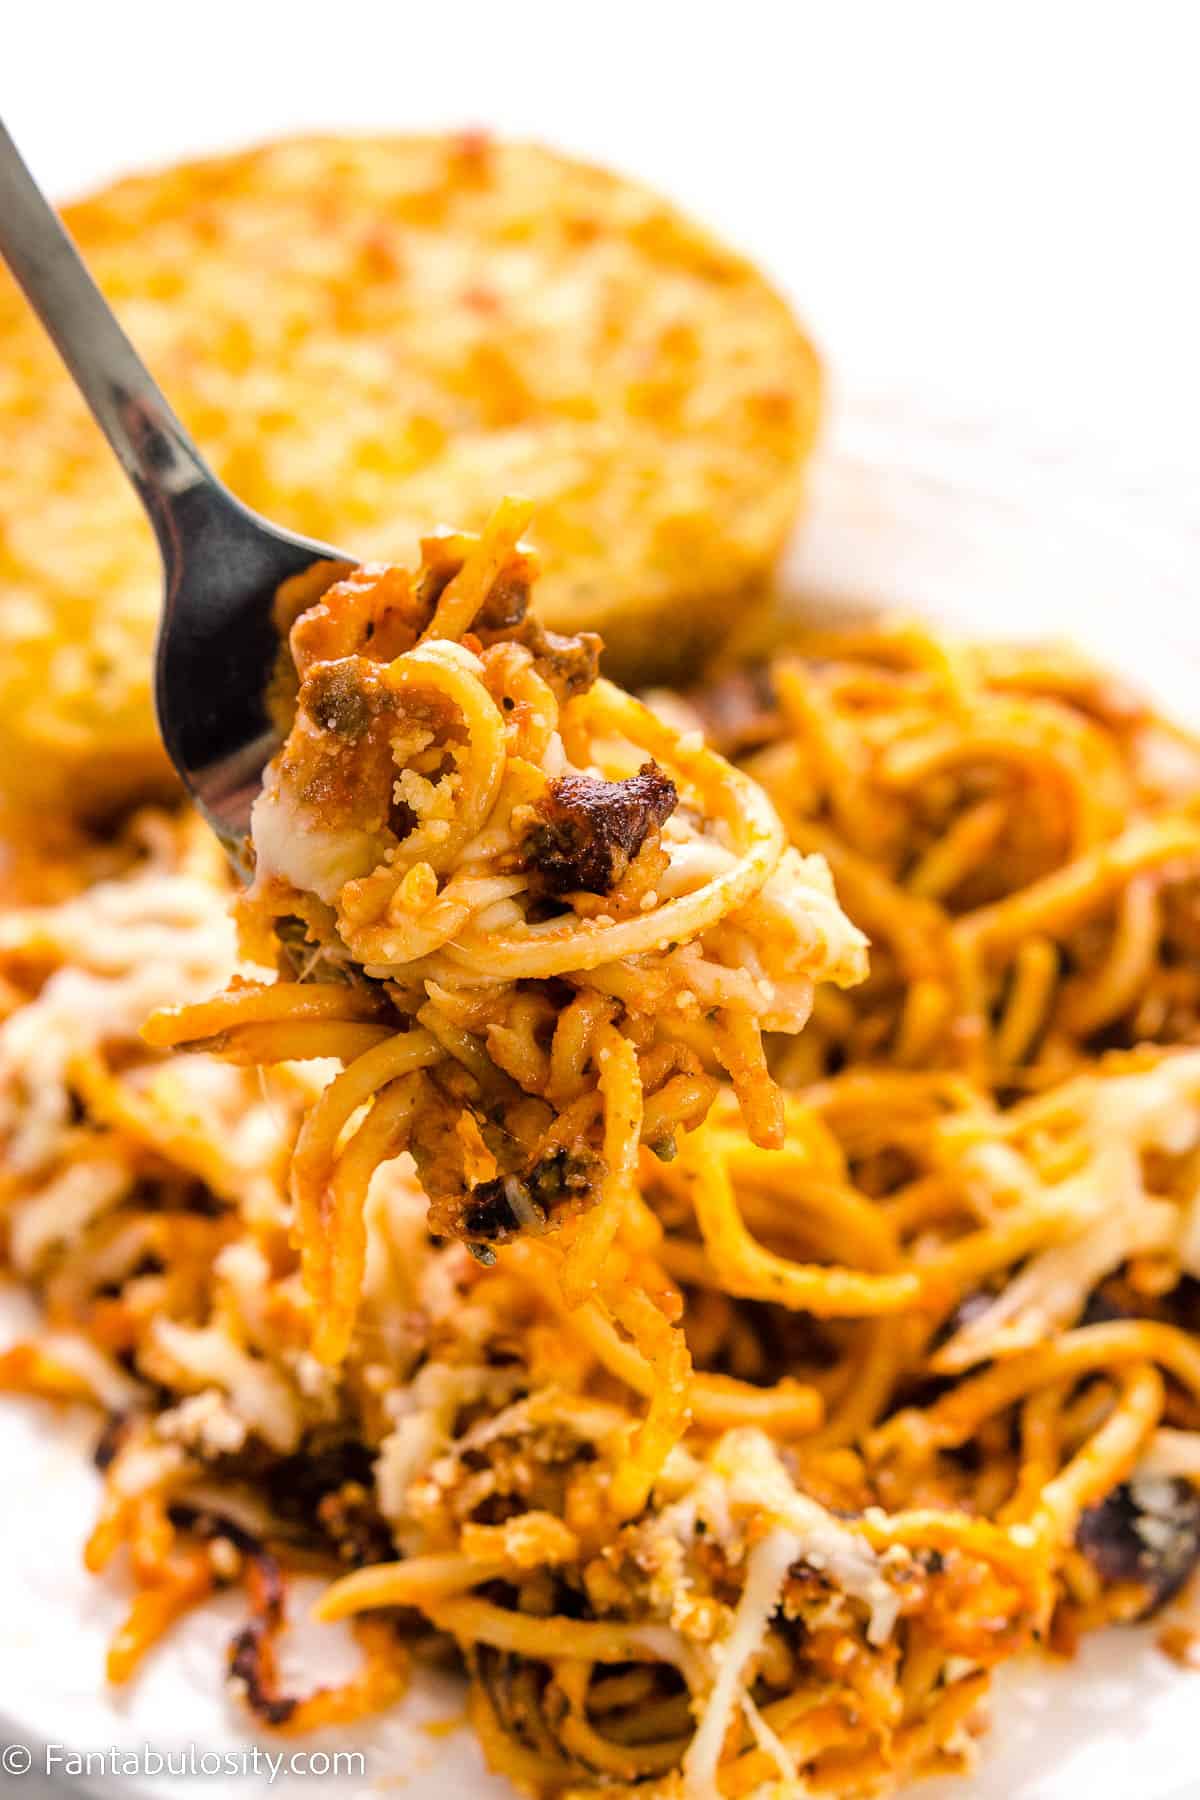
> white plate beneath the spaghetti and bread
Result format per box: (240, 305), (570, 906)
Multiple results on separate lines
(0, 405), (1200, 1800)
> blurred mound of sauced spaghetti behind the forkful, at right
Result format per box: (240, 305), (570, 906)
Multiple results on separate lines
(683, 621), (1200, 1089)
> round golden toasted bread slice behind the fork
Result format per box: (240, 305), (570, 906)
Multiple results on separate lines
(0, 133), (819, 799)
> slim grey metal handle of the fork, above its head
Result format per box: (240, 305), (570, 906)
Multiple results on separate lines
(0, 119), (215, 543)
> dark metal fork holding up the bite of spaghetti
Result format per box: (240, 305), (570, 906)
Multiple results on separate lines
(0, 121), (358, 878)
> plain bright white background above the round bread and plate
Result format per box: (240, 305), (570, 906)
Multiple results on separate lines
(0, 0), (1200, 522)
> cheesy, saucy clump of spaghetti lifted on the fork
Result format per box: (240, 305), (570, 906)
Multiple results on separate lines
(149, 500), (865, 1361)
